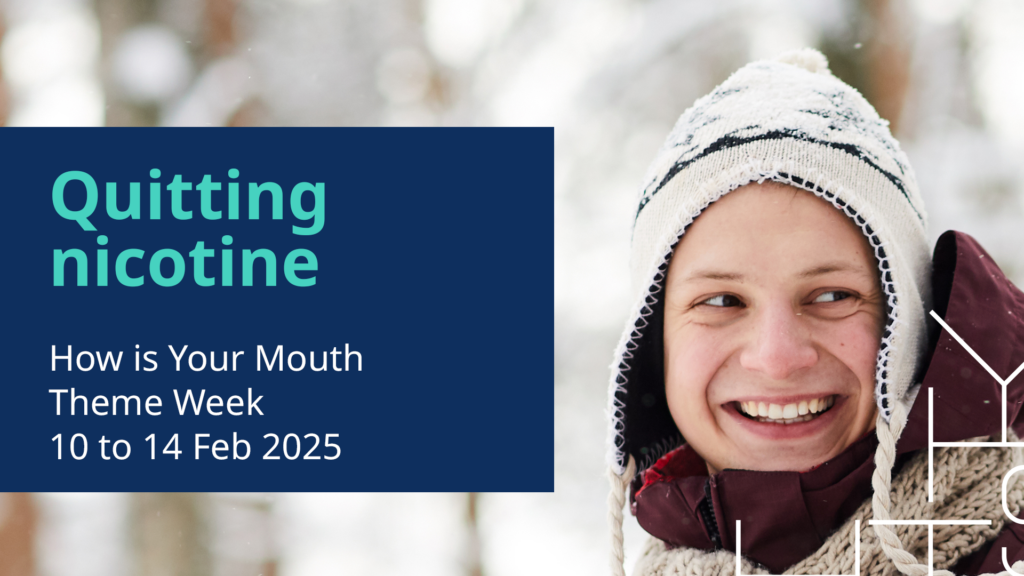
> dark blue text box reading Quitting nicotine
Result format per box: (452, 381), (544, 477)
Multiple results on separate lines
(0, 128), (554, 491)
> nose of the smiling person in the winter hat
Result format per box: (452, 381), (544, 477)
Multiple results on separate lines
(739, 301), (818, 380)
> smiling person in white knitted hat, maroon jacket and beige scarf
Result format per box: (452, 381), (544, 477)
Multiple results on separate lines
(608, 49), (1024, 576)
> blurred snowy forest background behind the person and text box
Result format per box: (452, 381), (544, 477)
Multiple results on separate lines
(0, 0), (1024, 576)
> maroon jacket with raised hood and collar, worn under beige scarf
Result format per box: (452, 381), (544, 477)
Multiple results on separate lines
(631, 232), (1024, 574)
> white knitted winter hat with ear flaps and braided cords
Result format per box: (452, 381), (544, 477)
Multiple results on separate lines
(608, 48), (931, 574)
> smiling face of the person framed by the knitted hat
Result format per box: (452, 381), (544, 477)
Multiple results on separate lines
(665, 182), (884, 472)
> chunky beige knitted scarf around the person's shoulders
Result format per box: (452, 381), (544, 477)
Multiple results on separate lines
(634, 420), (1024, 576)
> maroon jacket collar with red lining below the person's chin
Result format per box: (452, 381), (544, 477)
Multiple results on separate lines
(633, 434), (878, 574)
